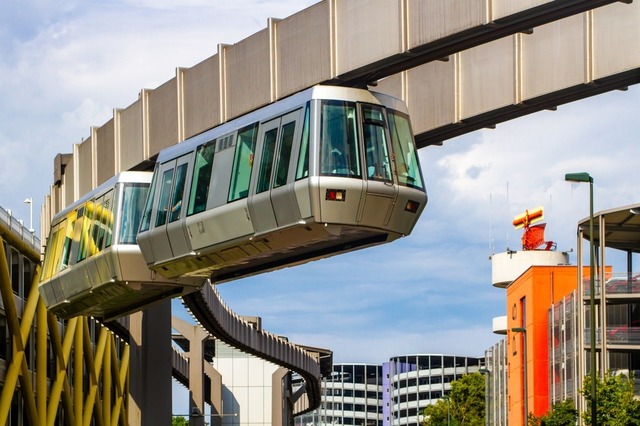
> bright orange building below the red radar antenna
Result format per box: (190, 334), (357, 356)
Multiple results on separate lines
(506, 266), (578, 425)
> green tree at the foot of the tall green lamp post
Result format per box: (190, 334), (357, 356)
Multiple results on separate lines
(580, 372), (640, 426)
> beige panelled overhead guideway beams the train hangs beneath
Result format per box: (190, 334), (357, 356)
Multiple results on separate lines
(51, 0), (640, 201)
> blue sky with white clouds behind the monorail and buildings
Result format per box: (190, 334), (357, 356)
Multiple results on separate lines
(0, 0), (640, 416)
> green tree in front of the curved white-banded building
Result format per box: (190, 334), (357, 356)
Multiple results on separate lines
(423, 373), (485, 426)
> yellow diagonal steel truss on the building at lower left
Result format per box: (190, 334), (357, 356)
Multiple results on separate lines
(0, 233), (129, 426)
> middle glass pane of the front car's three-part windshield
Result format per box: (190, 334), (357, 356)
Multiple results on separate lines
(362, 105), (392, 182)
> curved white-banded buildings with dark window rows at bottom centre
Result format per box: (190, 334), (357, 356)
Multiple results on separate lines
(295, 355), (482, 426)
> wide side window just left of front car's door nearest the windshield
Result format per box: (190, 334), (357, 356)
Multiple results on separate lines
(228, 123), (258, 202)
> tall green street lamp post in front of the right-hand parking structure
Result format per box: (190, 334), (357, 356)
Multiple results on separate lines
(564, 172), (597, 425)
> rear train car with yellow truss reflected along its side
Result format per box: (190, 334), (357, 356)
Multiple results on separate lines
(38, 172), (204, 319)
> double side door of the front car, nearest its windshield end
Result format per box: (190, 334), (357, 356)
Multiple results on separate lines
(249, 110), (300, 234)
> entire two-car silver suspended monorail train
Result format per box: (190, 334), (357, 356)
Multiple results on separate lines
(39, 86), (427, 318)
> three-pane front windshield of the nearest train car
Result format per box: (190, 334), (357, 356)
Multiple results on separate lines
(320, 101), (424, 189)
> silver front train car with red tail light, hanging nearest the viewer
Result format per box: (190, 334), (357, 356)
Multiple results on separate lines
(138, 86), (427, 283)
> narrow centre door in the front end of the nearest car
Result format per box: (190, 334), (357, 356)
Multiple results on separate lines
(361, 105), (398, 226)
